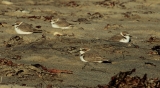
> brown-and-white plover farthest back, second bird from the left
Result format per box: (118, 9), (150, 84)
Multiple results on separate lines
(51, 18), (73, 29)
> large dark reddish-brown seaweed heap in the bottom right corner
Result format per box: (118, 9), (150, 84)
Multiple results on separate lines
(97, 69), (160, 88)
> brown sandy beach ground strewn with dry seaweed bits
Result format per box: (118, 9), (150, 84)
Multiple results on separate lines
(0, 0), (160, 88)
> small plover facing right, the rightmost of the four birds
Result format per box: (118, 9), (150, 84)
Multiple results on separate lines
(109, 31), (131, 43)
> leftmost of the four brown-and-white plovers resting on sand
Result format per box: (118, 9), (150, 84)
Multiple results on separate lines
(14, 22), (42, 34)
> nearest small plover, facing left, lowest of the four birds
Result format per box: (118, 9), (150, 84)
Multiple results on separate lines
(80, 48), (111, 63)
